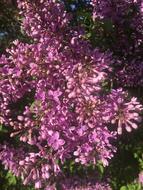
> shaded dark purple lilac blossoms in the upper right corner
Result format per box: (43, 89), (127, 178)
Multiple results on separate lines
(91, 0), (143, 87)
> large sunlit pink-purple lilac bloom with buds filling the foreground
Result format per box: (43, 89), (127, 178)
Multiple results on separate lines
(0, 0), (143, 190)
